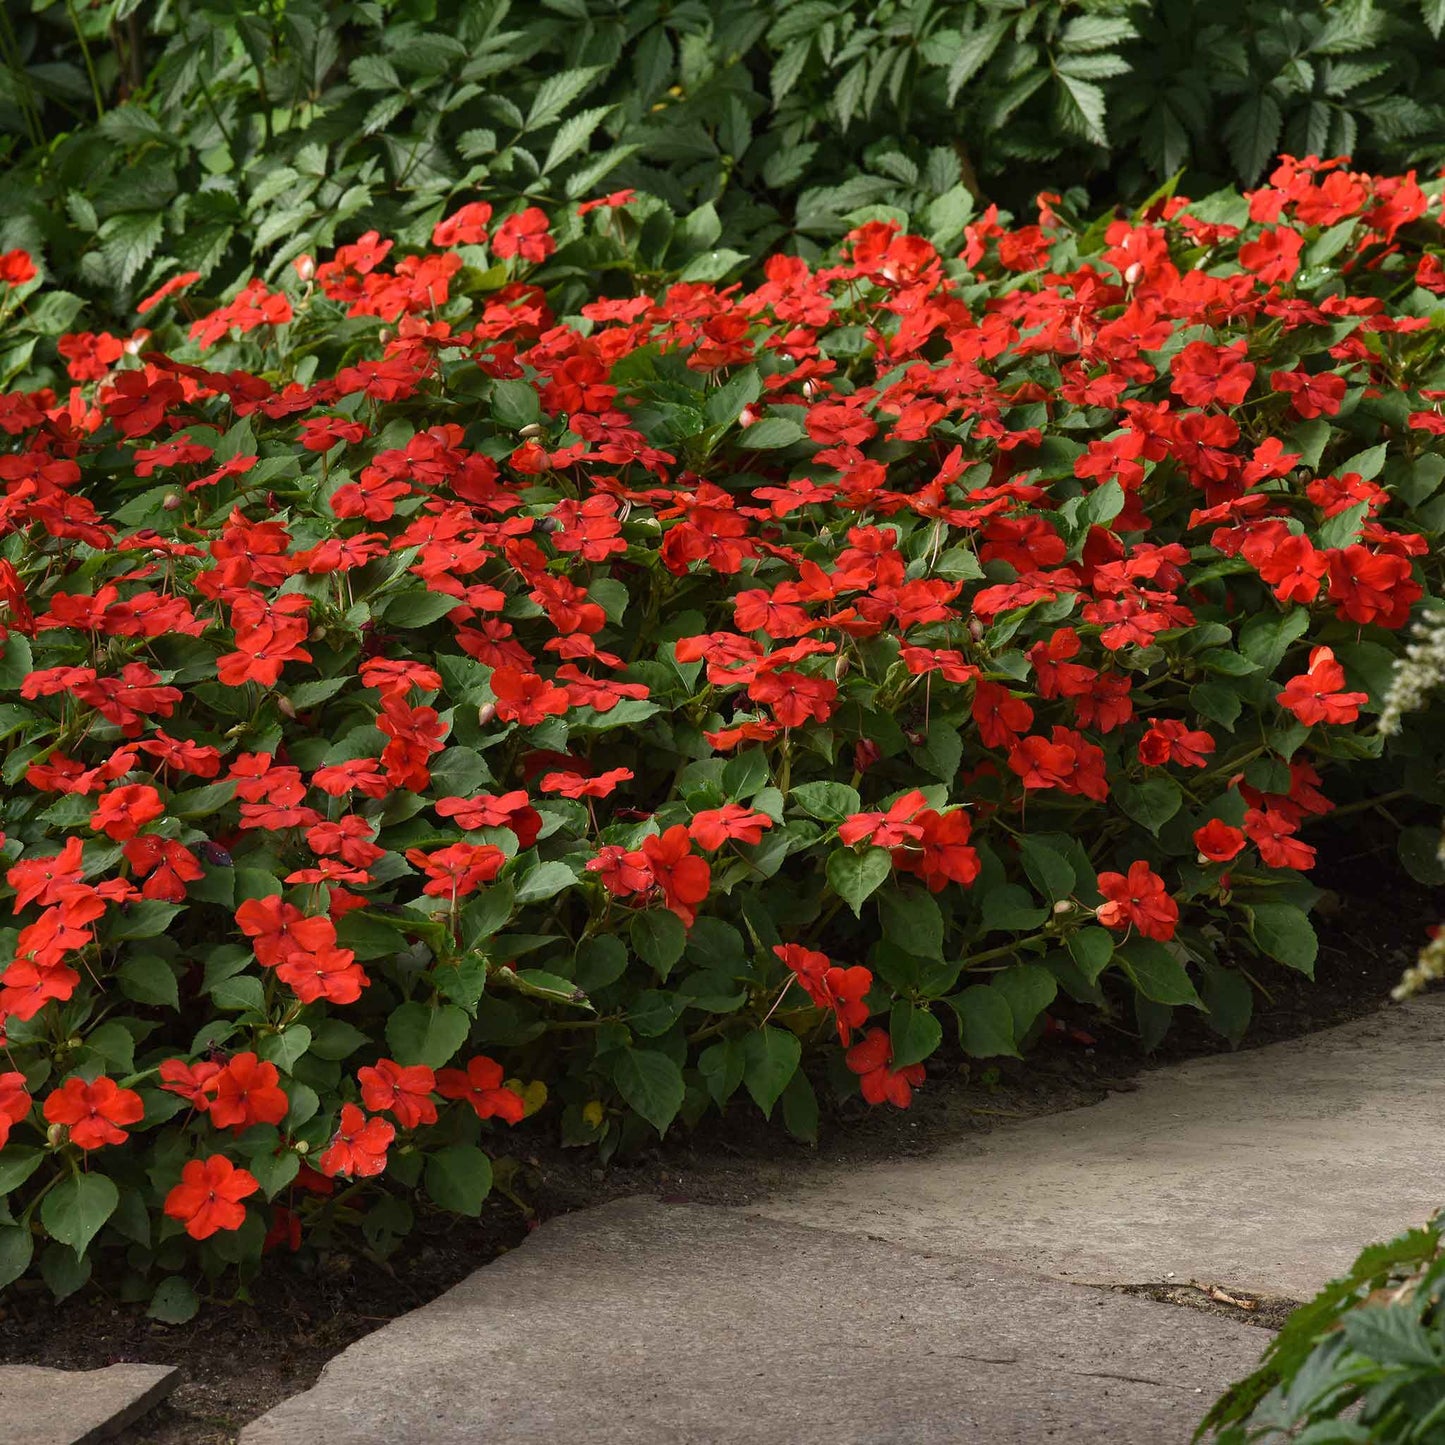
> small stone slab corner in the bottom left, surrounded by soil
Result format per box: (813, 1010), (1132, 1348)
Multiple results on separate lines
(0, 1364), (181, 1445)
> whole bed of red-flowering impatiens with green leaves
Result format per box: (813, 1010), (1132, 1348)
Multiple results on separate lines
(0, 160), (1445, 1318)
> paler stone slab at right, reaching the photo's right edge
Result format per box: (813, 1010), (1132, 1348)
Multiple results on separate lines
(759, 994), (1445, 1299)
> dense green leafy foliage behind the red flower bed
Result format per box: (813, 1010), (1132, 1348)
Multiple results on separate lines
(0, 0), (1445, 312)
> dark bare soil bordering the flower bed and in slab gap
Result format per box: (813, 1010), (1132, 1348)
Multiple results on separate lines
(0, 829), (1441, 1445)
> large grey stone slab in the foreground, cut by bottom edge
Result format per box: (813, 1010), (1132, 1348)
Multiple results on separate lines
(241, 1199), (1267, 1445)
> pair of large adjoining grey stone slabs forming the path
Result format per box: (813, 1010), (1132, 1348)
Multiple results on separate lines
(241, 997), (1445, 1445)
